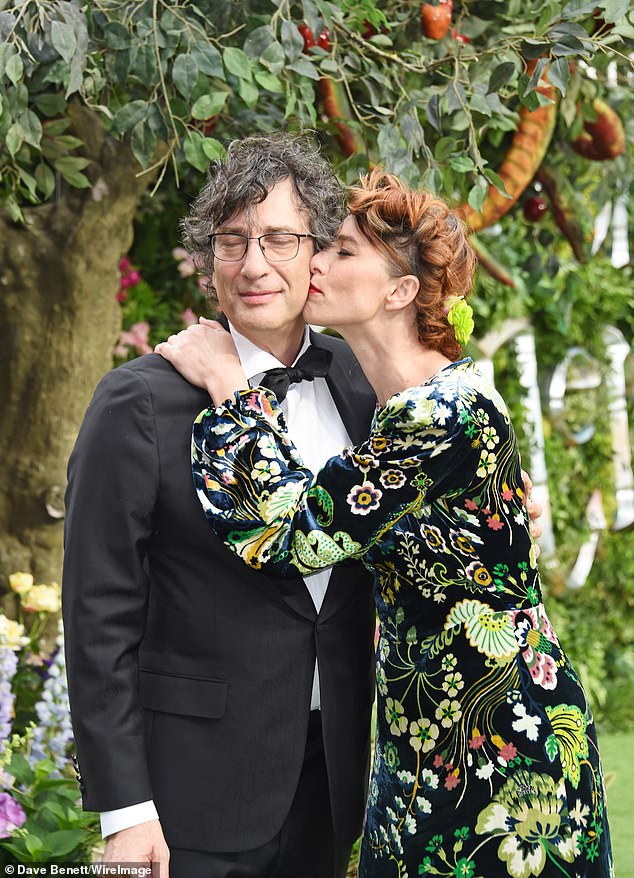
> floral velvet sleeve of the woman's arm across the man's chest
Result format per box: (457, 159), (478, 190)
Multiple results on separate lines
(192, 363), (508, 576)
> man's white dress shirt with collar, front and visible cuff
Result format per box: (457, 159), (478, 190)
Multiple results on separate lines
(100, 324), (351, 838)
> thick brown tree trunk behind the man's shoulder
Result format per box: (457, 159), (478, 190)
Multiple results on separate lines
(0, 105), (157, 596)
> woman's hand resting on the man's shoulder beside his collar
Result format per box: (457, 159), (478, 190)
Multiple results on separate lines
(154, 317), (249, 405)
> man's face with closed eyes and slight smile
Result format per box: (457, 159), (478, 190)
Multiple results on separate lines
(213, 179), (313, 348)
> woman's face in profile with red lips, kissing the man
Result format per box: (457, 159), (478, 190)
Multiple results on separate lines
(304, 216), (396, 328)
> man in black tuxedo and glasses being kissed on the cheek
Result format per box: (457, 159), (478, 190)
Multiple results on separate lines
(63, 135), (374, 878)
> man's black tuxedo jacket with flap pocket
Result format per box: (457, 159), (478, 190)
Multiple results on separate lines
(62, 334), (374, 852)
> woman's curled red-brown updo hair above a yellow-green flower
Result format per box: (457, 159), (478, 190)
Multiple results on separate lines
(348, 168), (476, 360)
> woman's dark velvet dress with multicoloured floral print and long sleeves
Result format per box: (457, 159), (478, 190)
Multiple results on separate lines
(192, 359), (613, 878)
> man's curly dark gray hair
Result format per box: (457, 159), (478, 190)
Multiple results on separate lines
(182, 132), (345, 286)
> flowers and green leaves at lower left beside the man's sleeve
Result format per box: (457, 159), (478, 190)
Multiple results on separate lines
(0, 572), (99, 866)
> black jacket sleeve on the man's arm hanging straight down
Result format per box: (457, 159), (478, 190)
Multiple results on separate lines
(62, 367), (158, 811)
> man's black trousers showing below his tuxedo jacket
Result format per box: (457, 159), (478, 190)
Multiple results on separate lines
(169, 711), (351, 878)
